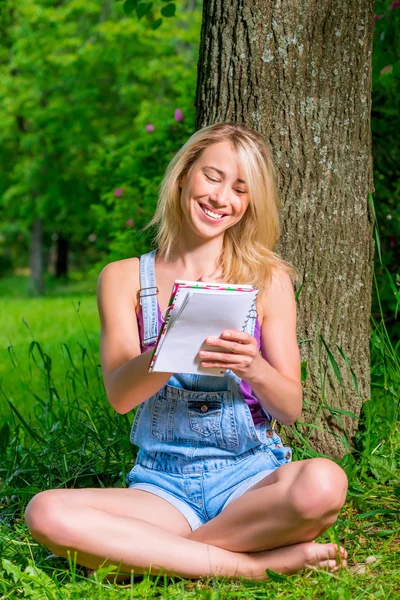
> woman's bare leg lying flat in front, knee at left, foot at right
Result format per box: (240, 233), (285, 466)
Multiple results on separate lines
(26, 490), (346, 579)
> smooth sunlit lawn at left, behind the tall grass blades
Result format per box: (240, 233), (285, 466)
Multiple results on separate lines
(0, 276), (100, 422)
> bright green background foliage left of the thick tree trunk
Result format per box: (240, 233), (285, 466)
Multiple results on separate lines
(0, 0), (200, 270)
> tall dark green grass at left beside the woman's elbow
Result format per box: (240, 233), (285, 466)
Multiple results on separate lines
(0, 308), (132, 496)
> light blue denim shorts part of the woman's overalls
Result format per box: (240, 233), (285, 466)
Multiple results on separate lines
(127, 440), (288, 530)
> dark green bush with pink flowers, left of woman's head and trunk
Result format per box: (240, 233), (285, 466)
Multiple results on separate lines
(87, 5), (200, 268)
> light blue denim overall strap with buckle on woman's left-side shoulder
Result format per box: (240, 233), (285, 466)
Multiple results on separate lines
(139, 250), (158, 346)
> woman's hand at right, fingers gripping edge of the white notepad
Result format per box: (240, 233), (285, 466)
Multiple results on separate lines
(199, 329), (264, 381)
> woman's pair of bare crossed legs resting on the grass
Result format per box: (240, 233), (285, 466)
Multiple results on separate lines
(26, 459), (346, 579)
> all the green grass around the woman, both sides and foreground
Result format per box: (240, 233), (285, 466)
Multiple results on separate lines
(0, 270), (400, 600)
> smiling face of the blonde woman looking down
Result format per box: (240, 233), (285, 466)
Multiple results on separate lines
(180, 142), (249, 238)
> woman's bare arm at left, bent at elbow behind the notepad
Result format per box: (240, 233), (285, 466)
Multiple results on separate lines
(97, 259), (171, 414)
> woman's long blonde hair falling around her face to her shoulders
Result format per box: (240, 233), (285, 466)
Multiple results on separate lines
(146, 123), (297, 291)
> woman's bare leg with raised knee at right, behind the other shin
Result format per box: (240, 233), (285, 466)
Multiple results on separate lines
(187, 458), (347, 552)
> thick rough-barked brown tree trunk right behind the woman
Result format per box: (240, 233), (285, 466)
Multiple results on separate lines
(196, 0), (374, 456)
